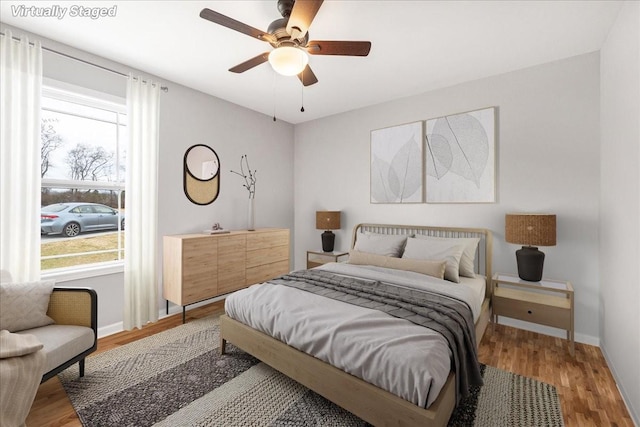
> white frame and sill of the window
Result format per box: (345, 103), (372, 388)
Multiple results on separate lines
(40, 78), (127, 282)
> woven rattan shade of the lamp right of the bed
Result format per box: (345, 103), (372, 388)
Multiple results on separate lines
(505, 214), (556, 246)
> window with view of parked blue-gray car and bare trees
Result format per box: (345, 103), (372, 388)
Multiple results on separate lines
(40, 85), (127, 273)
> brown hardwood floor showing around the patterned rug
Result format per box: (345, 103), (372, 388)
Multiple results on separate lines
(27, 301), (634, 427)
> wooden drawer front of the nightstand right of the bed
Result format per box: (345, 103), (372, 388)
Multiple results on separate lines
(493, 295), (571, 329)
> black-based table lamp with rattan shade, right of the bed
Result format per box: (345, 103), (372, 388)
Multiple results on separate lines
(505, 213), (556, 282)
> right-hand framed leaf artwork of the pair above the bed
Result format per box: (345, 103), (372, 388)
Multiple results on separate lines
(425, 107), (496, 203)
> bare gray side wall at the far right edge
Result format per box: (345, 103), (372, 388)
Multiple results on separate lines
(600, 1), (640, 423)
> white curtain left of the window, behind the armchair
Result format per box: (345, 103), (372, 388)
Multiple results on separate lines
(0, 30), (42, 281)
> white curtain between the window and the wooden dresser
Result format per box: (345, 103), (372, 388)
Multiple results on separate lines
(124, 76), (160, 330)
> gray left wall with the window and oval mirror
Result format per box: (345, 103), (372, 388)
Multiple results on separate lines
(2, 24), (294, 334)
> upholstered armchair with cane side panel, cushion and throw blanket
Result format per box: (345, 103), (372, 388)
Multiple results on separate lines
(0, 271), (98, 426)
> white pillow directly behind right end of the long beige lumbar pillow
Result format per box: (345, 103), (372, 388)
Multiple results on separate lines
(402, 237), (464, 283)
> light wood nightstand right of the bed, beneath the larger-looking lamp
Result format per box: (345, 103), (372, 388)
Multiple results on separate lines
(491, 273), (575, 356)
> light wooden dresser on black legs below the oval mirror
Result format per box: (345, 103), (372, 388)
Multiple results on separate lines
(162, 228), (289, 321)
